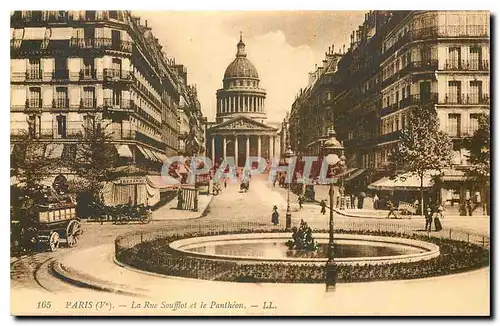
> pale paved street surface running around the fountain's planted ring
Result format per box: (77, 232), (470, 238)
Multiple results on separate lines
(11, 176), (489, 314)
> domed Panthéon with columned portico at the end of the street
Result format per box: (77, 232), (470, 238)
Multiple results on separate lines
(207, 37), (279, 167)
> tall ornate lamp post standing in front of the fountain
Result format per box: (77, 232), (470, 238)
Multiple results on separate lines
(323, 128), (345, 291)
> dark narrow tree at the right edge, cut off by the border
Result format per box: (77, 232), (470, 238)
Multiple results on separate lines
(465, 114), (491, 214)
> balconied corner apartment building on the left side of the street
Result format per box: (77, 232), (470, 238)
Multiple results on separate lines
(11, 10), (202, 171)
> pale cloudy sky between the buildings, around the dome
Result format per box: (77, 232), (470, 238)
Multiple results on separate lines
(133, 11), (365, 122)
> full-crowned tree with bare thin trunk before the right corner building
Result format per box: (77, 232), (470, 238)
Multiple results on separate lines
(390, 107), (452, 215)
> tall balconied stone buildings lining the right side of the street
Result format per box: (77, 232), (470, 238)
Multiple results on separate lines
(290, 11), (490, 211)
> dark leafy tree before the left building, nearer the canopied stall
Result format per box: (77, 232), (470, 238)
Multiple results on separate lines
(70, 121), (118, 209)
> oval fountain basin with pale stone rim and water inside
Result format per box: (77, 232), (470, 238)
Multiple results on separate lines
(169, 233), (439, 265)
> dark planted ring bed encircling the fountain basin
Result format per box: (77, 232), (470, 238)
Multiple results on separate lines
(116, 230), (489, 283)
